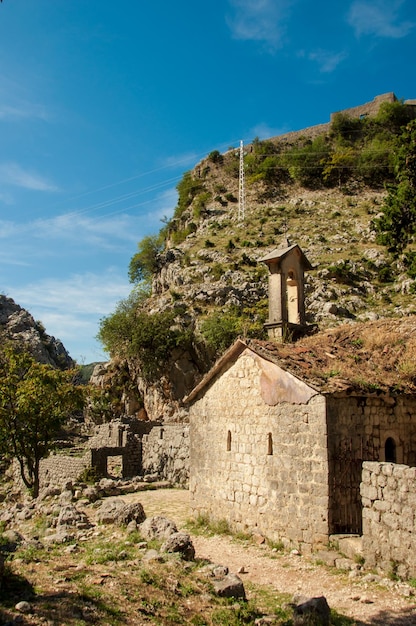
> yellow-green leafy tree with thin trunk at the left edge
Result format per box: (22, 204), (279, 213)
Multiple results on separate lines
(0, 344), (84, 497)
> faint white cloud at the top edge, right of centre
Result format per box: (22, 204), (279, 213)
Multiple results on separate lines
(227, 0), (294, 51)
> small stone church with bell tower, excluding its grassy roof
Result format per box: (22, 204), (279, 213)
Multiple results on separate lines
(186, 241), (416, 552)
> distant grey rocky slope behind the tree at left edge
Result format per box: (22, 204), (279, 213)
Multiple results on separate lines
(0, 295), (74, 369)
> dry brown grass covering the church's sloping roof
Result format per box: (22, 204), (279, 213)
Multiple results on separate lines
(256, 316), (416, 393)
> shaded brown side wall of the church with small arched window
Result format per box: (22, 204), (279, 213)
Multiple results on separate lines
(327, 396), (416, 534)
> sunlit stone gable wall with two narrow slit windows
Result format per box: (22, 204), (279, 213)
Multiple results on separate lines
(190, 350), (328, 551)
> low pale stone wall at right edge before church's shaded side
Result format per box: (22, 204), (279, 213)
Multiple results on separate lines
(361, 462), (416, 578)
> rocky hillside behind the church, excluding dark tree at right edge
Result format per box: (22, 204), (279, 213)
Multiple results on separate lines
(96, 96), (415, 420)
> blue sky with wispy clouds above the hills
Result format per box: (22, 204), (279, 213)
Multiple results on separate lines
(0, 0), (416, 363)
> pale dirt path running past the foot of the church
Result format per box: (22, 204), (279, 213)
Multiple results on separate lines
(123, 489), (416, 626)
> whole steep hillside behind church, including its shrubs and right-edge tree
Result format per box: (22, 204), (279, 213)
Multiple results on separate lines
(99, 97), (416, 416)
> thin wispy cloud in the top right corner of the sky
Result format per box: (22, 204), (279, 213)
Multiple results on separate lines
(348, 0), (415, 39)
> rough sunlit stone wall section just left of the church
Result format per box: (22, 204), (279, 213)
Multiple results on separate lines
(142, 424), (189, 486)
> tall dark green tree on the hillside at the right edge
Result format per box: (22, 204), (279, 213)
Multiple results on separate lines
(375, 120), (416, 256)
